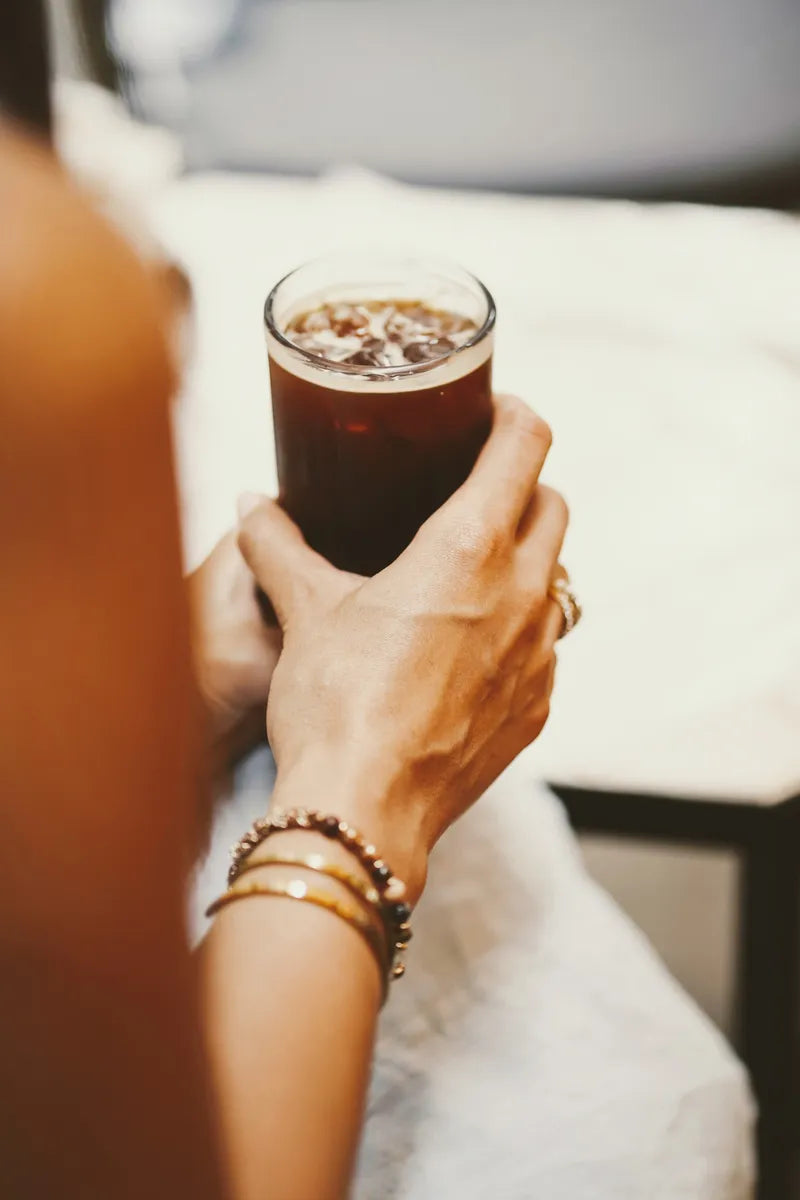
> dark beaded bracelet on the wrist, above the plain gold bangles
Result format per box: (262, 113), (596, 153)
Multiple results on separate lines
(228, 809), (413, 979)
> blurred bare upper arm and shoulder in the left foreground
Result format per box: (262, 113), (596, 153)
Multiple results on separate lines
(0, 126), (223, 1200)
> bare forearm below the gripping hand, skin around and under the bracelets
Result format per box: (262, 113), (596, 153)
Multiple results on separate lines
(200, 772), (425, 1200)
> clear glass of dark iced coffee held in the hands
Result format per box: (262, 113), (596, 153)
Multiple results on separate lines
(264, 254), (495, 575)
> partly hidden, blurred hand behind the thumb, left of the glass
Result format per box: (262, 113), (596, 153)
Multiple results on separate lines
(188, 530), (281, 760)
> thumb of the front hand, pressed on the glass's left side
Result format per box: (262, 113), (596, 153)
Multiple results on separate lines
(237, 494), (335, 628)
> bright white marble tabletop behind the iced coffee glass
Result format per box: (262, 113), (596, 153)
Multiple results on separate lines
(58, 85), (800, 804)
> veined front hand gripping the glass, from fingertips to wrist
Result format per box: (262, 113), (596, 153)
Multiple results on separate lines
(239, 397), (567, 894)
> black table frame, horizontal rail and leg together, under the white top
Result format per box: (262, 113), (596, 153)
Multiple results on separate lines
(552, 785), (800, 1200)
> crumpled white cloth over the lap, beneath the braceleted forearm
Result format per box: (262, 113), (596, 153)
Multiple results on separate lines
(194, 750), (753, 1200)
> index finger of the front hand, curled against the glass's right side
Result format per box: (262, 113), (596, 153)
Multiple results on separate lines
(449, 396), (552, 529)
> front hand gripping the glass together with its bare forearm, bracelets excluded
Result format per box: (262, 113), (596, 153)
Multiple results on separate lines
(201, 400), (566, 1200)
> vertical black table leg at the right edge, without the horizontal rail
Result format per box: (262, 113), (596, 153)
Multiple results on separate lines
(736, 806), (800, 1200)
